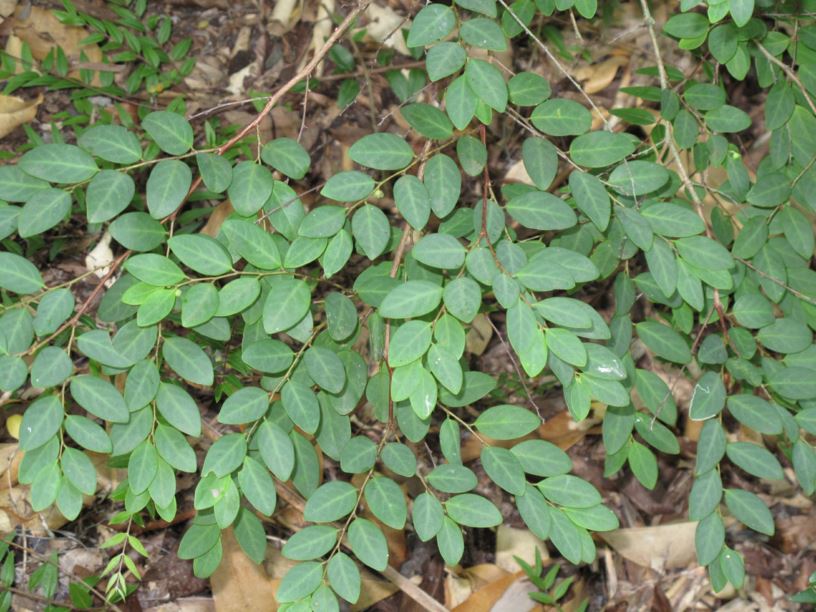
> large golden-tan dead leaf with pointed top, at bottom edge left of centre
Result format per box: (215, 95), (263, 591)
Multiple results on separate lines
(210, 529), (278, 612)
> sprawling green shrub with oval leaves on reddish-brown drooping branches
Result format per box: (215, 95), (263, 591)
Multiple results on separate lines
(0, 0), (816, 610)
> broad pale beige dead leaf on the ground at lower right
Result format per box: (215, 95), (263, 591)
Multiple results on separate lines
(598, 521), (697, 571)
